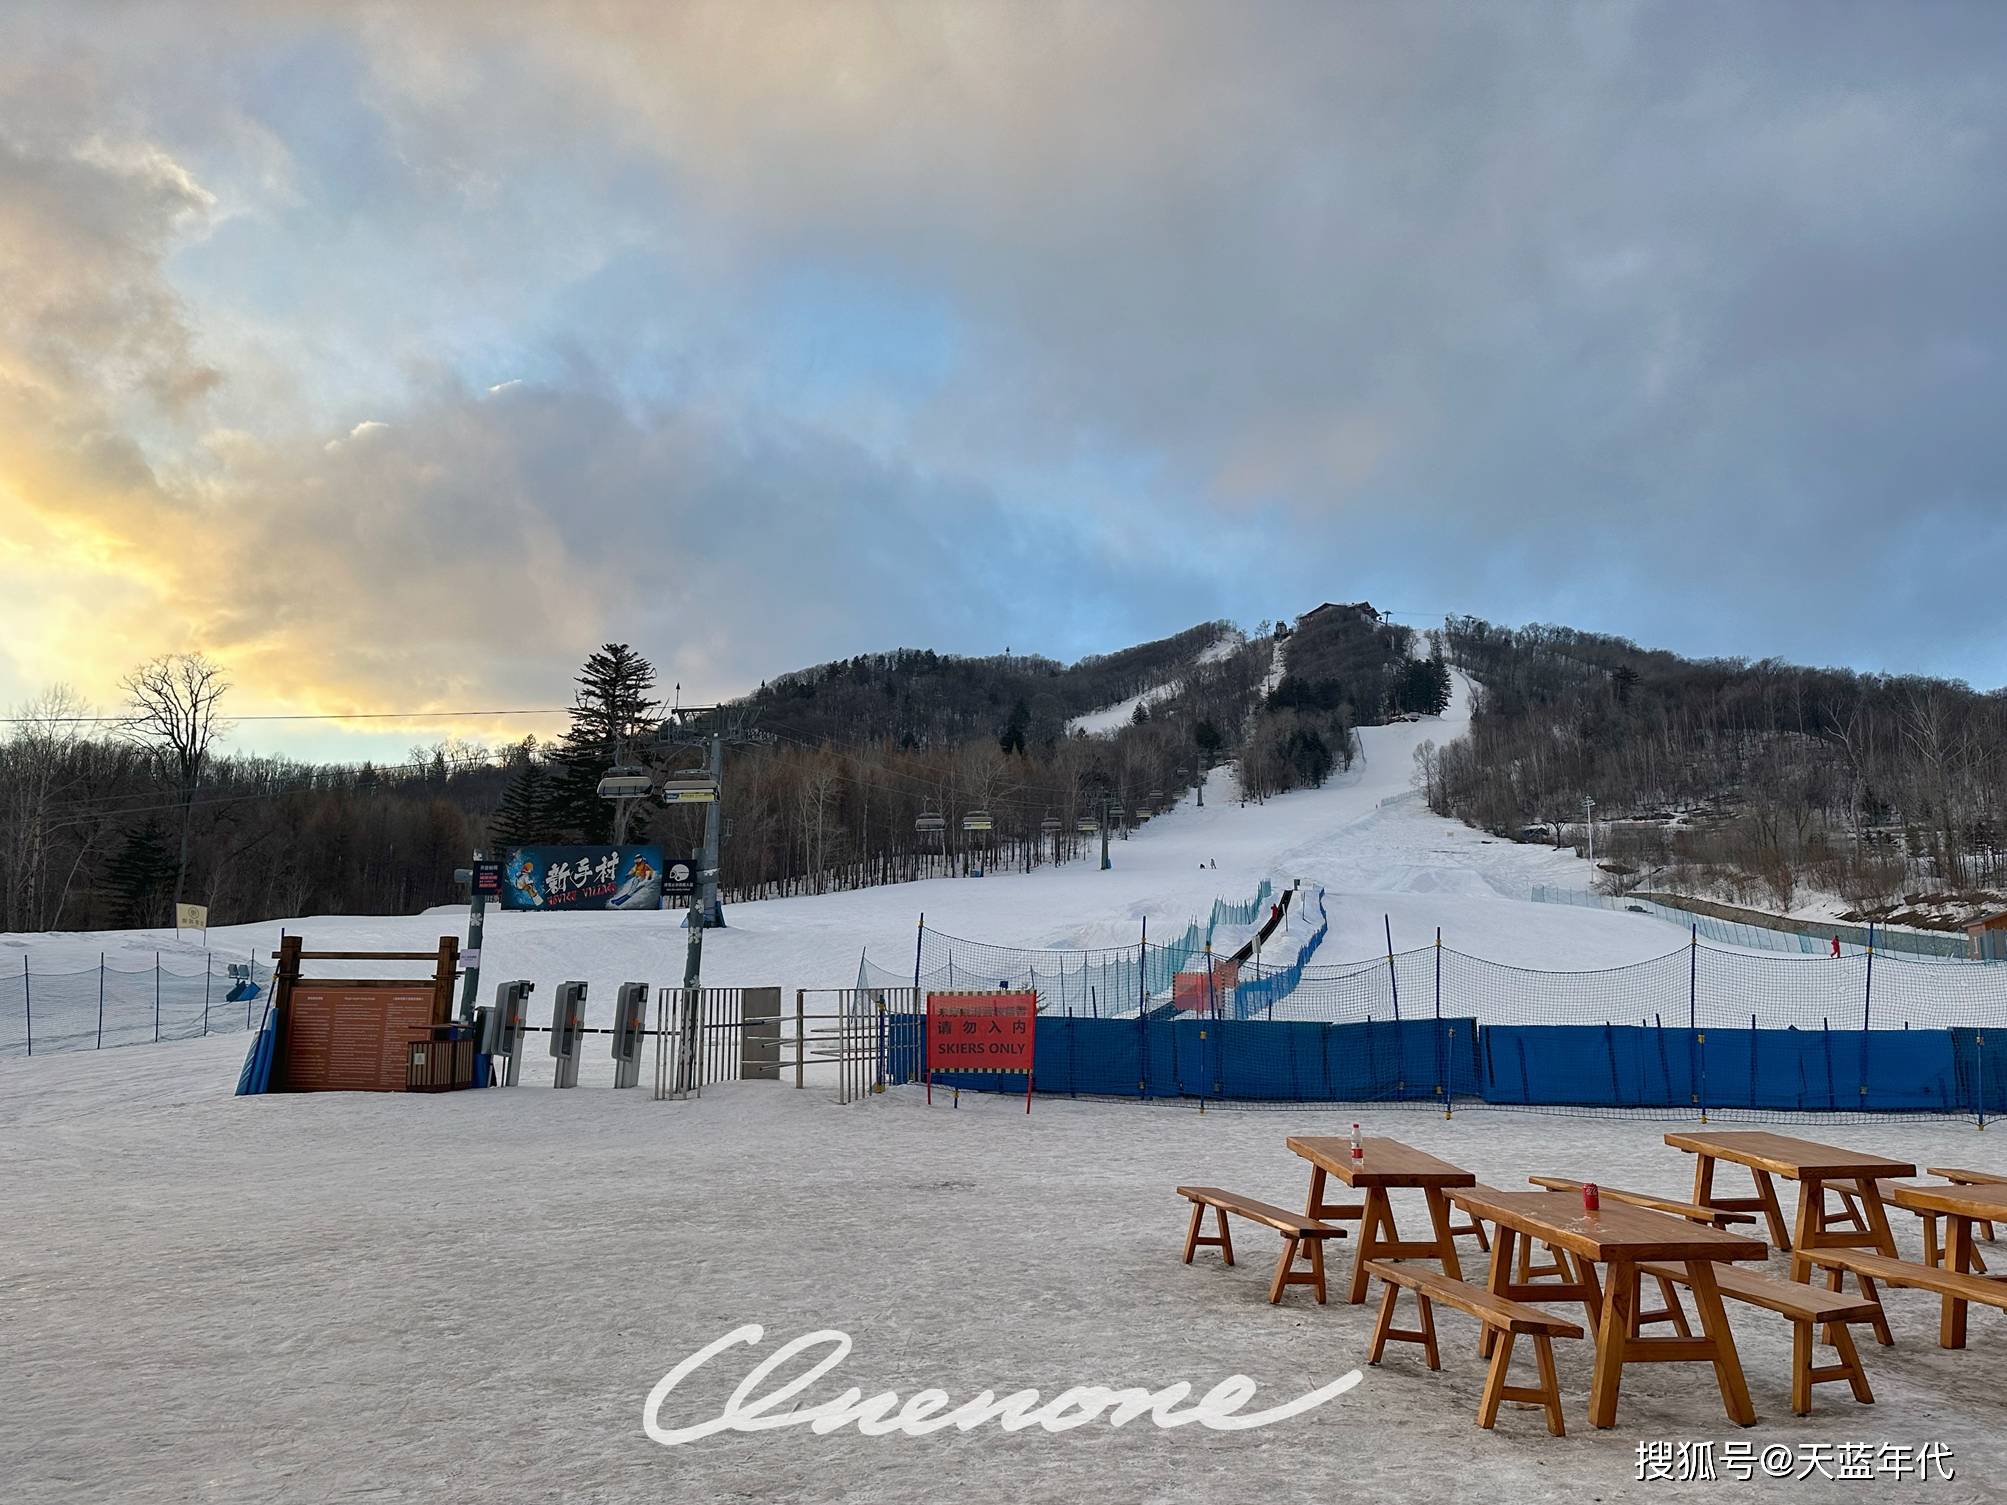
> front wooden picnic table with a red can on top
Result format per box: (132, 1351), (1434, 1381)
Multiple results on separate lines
(1449, 1186), (1770, 1427)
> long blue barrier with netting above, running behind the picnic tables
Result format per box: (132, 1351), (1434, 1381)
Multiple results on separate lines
(863, 925), (2007, 1124)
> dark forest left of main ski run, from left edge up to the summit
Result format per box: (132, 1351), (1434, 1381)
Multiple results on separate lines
(0, 604), (1449, 931)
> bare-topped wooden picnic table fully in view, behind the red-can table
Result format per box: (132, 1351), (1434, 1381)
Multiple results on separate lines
(1666, 1130), (1917, 1280)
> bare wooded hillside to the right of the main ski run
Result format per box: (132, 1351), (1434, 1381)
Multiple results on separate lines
(1419, 616), (2007, 915)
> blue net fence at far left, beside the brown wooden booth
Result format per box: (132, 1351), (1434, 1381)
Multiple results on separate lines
(0, 951), (271, 1056)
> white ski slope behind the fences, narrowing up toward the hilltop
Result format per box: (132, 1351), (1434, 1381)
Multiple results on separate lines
(0, 676), (1709, 1021)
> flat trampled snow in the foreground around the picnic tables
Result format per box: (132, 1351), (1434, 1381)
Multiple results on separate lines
(0, 1039), (2007, 1505)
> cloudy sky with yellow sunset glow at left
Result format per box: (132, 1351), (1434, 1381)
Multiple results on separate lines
(0, 0), (2007, 759)
